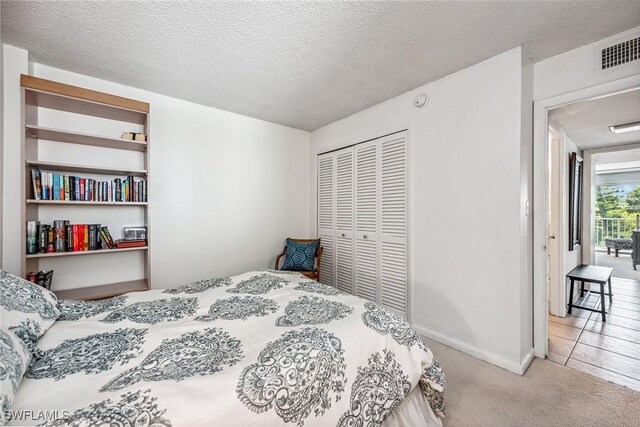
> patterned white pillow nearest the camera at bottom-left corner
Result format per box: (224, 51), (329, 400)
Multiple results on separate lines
(0, 327), (31, 425)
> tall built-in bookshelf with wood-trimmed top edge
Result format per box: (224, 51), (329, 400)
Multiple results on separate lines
(21, 75), (151, 300)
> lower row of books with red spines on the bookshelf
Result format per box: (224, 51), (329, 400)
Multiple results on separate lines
(27, 220), (147, 255)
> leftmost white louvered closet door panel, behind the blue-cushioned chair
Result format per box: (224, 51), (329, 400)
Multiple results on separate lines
(318, 153), (335, 286)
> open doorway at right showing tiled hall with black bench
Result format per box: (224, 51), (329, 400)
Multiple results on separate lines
(536, 87), (640, 390)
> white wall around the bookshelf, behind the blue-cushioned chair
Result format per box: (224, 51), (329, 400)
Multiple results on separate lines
(3, 46), (310, 288)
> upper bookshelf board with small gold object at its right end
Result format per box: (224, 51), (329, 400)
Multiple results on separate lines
(25, 124), (147, 151)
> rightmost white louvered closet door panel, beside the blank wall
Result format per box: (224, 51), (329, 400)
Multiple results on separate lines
(380, 132), (408, 317)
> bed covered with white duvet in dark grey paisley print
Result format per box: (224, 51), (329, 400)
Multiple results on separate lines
(1, 270), (445, 426)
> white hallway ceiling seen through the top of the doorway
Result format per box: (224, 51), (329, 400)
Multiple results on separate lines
(550, 88), (640, 150)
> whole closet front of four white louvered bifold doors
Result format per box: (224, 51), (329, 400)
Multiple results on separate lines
(317, 131), (408, 318)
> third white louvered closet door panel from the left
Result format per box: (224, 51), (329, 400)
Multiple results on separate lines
(355, 141), (379, 302)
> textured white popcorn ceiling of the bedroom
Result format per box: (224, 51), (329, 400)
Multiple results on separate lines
(2, 0), (640, 130)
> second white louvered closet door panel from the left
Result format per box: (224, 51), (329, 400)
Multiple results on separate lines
(335, 147), (355, 293)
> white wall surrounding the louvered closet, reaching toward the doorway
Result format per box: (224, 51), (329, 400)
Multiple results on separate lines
(310, 48), (532, 372)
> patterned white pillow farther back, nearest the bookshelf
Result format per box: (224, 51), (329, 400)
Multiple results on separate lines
(0, 270), (60, 351)
